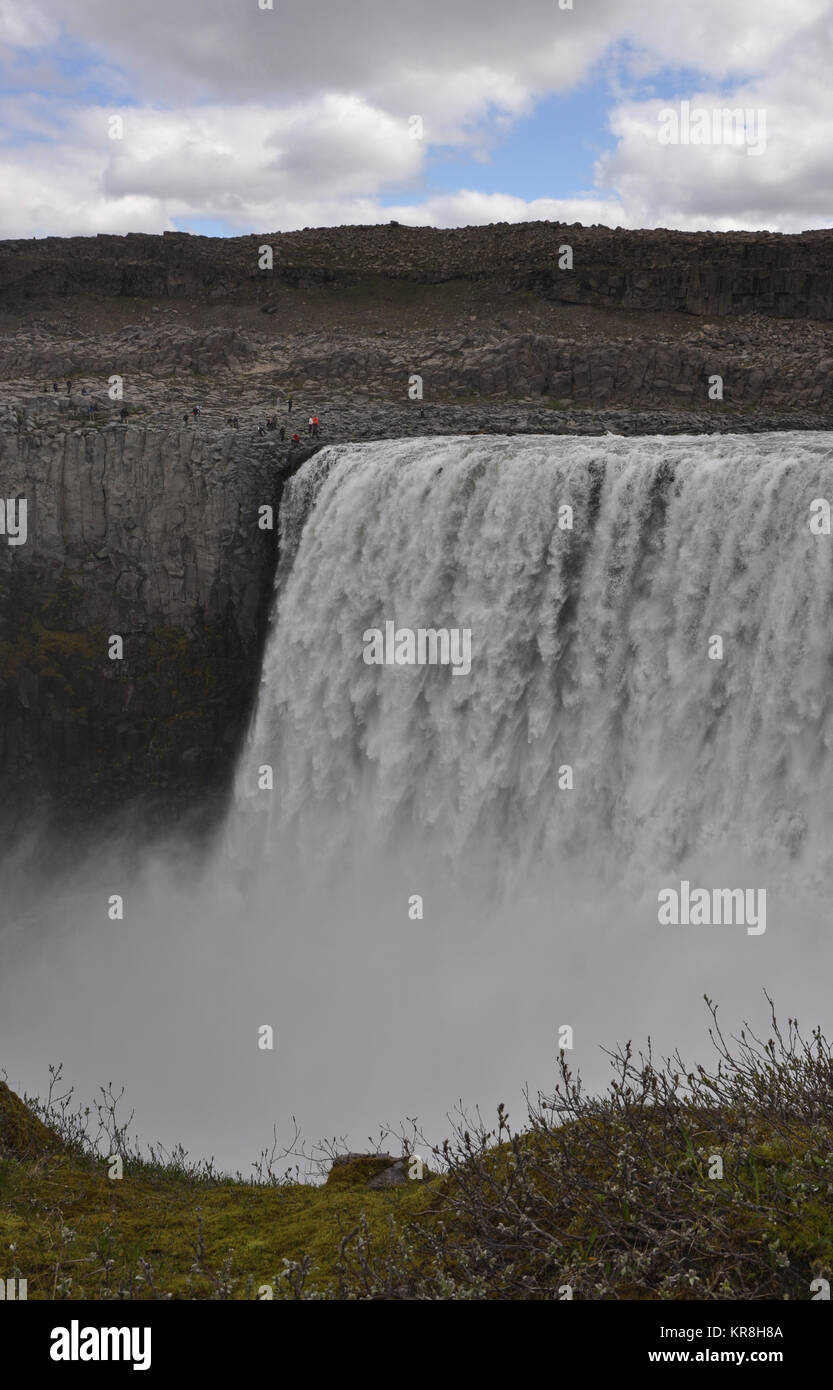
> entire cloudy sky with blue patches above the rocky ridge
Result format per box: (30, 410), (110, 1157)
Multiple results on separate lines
(0, 0), (833, 238)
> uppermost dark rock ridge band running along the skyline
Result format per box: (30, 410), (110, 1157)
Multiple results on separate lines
(0, 222), (833, 320)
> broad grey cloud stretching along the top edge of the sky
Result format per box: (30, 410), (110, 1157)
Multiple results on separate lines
(32, 0), (830, 109)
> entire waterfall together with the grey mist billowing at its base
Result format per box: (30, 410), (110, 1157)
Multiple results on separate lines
(0, 434), (833, 1170)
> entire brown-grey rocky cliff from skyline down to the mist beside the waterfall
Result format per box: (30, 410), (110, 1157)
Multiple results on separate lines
(0, 222), (833, 821)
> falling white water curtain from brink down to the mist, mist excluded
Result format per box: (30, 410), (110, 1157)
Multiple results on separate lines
(234, 434), (833, 881)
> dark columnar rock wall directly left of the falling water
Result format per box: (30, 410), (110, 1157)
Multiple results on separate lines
(0, 411), (285, 812)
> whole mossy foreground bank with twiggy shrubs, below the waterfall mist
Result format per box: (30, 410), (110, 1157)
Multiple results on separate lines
(0, 1001), (833, 1300)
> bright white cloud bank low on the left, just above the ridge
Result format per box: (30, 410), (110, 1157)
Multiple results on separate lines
(0, 96), (424, 236)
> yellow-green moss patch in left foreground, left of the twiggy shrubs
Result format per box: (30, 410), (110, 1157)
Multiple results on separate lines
(0, 1134), (436, 1298)
